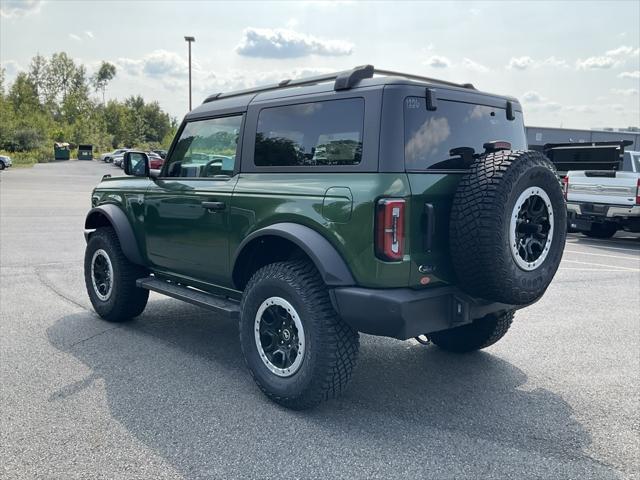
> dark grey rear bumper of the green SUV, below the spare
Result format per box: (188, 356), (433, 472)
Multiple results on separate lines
(331, 287), (525, 340)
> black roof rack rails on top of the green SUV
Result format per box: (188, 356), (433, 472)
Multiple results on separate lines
(203, 65), (475, 103)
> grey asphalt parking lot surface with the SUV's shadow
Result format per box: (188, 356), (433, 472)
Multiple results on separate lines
(0, 161), (640, 479)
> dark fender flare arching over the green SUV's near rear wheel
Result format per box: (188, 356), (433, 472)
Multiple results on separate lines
(232, 222), (356, 286)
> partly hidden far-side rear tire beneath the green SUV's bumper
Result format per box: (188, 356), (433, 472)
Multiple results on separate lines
(429, 310), (514, 353)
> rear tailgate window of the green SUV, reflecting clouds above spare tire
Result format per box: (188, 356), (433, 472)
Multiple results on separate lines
(404, 97), (527, 170)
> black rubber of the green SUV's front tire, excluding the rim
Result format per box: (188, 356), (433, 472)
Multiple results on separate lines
(84, 227), (149, 322)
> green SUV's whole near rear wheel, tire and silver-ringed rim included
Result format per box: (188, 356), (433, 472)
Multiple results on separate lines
(240, 260), (359, 410)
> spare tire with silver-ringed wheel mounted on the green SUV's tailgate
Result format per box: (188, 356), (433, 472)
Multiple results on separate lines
(449, 150), (567, 305)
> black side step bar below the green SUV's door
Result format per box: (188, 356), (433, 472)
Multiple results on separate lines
(136, 277), (240, 318)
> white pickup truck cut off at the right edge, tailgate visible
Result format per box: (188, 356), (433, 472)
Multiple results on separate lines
(563, 151), (640, 238)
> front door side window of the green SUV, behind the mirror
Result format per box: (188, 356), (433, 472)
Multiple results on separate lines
(166, 115), (242, 178)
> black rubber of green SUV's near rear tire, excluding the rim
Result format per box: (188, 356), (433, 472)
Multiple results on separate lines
(240, 260), (359, 410)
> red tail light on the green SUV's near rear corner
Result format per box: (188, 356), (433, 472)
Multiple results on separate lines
(375, 198), (405, 262)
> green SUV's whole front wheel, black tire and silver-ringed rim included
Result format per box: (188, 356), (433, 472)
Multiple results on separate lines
(84, 227), (149, 322)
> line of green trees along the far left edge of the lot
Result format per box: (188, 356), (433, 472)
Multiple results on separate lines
(0, 52), (177, 156)
